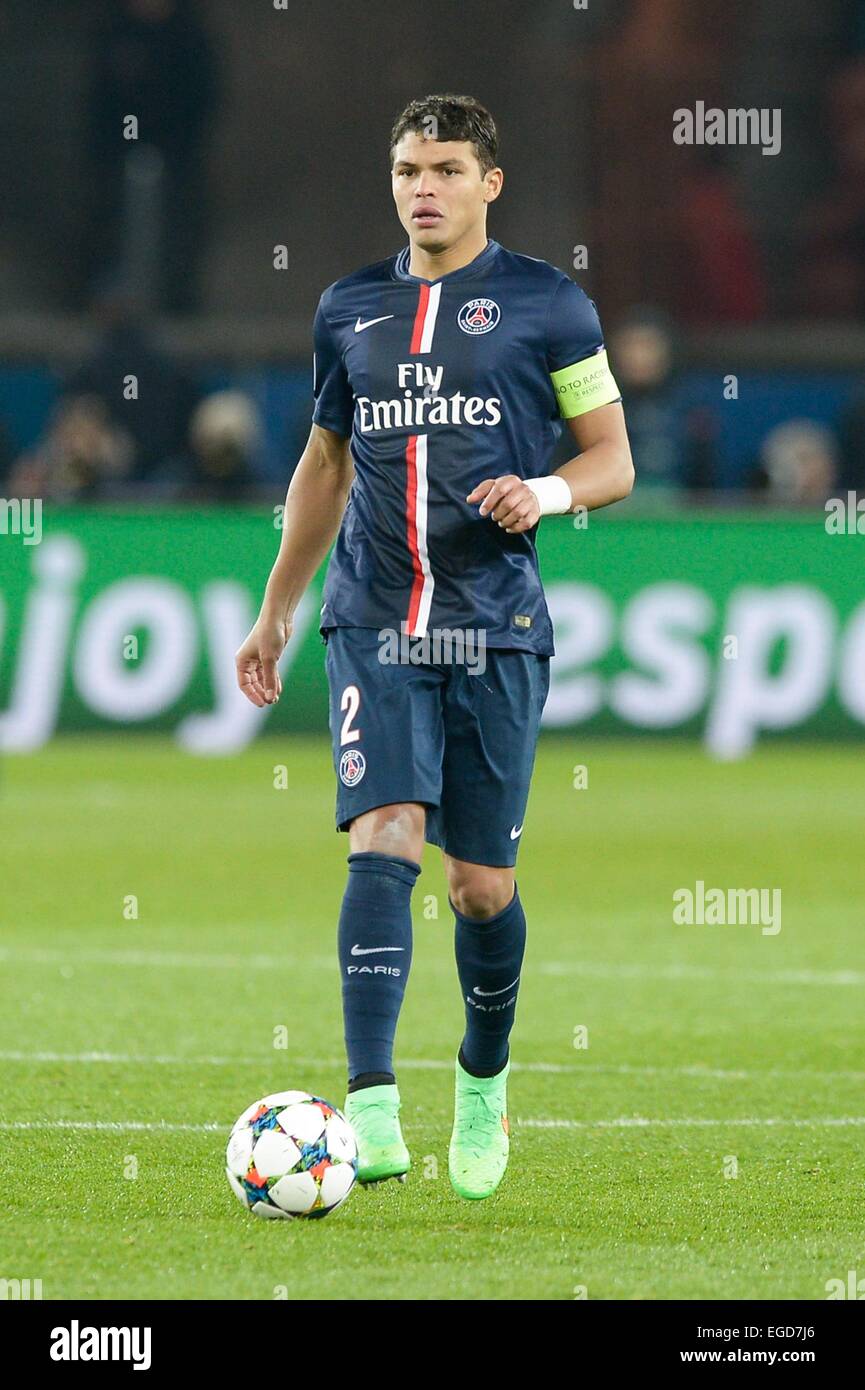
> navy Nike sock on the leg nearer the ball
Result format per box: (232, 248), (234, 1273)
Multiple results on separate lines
(338, 851), (420, 1090)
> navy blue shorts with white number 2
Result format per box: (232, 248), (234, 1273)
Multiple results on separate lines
(324, 627), (549, 866)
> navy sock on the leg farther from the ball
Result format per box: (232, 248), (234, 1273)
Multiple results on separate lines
(451, 884), (526, 1076)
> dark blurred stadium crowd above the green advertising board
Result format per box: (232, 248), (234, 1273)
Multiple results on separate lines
(0, 0), (865, 505)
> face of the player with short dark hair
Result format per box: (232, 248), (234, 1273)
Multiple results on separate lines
(391, 132), (503, 252)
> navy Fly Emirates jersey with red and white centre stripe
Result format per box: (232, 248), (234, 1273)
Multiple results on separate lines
(313, 240), (620, 656)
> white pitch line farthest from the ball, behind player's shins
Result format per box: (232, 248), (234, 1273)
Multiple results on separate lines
(0, 947), (865, 987)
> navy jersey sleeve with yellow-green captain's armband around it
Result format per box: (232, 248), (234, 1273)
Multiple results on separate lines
(547, 279), (622, 420)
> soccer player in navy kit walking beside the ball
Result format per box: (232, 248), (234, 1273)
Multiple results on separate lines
(236, 96), (633, 1198)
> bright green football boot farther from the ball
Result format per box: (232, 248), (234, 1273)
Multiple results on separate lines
(448, 1058), (510, 1201)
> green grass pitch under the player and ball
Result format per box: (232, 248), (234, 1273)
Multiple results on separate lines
(0, 735), (865, 1300)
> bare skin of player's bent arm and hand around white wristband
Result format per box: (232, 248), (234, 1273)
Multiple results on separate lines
(466, 400), (634, 535)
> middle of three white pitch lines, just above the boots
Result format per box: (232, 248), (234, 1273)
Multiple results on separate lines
(0, 1051), (865, 1081)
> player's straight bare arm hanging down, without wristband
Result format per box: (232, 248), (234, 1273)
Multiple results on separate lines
(235, 425), (355, 708)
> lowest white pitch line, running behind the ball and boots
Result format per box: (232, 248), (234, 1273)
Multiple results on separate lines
(0, 1115), (865, 1134)
